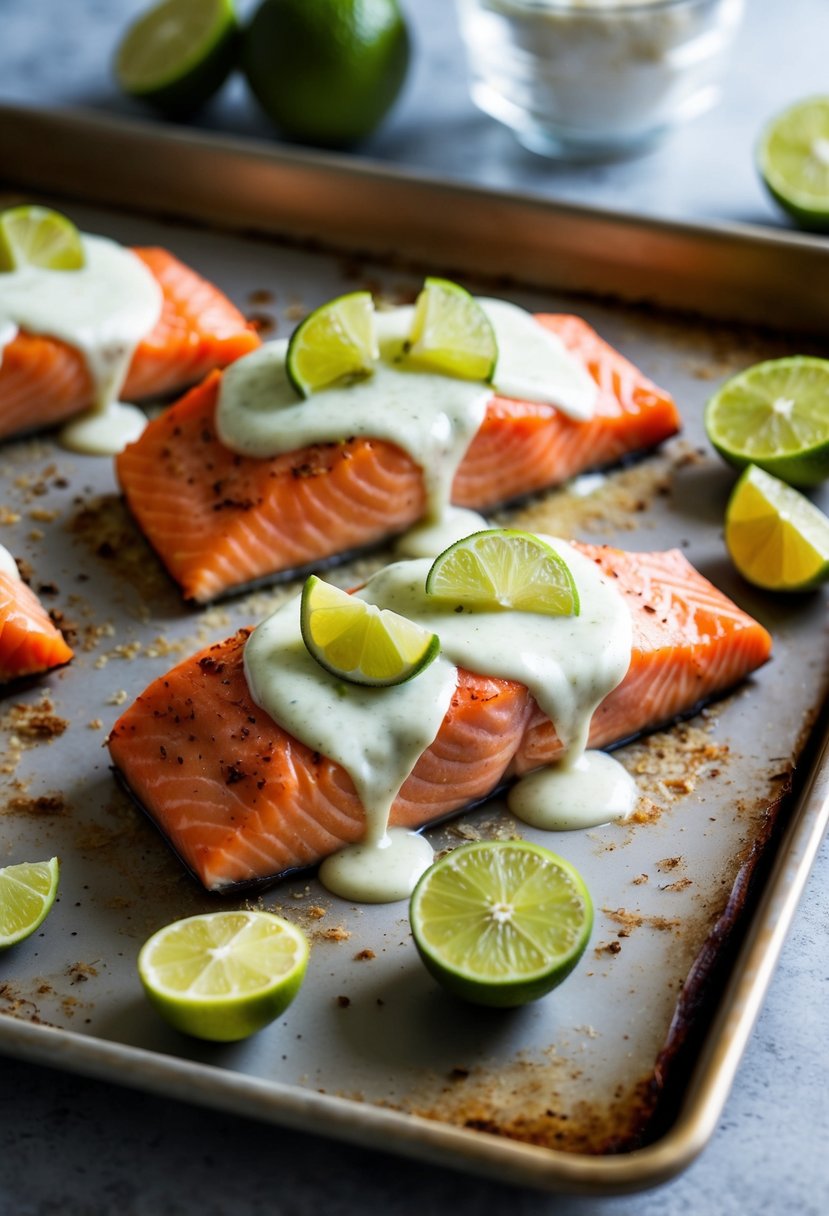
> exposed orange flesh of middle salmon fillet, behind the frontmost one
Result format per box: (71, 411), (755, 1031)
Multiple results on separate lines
(115, 315), (679, 603)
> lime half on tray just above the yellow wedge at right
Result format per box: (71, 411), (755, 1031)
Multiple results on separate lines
(705, 355), (829, 485)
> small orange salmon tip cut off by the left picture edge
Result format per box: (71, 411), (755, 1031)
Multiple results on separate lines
(0, 570), (73, 683)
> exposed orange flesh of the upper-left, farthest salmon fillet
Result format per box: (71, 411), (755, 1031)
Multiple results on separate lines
(0, 248), (260, 439)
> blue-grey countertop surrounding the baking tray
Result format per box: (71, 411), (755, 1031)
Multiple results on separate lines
(0, 0), (829, 1216)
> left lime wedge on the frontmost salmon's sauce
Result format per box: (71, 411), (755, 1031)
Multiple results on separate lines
(300, 574), (440, 688)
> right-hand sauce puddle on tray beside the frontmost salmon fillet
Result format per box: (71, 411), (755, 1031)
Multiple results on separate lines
(507, 751), (637, 832)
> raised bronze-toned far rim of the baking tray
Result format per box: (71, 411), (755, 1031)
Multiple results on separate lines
(0, 105), (829, 333)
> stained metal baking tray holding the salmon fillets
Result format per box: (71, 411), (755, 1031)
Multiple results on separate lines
(0, 111), (829, 1192)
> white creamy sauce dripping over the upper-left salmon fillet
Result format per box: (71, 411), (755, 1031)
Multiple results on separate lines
(0, 235), (163, 452)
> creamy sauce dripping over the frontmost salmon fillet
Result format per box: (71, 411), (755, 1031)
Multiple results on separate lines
(244, 537), (632, 902)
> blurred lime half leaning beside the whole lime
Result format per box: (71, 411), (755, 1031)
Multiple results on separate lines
(114, 0), (238, 116)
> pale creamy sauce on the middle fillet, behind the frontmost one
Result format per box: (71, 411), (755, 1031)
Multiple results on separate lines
(216, 299), (597, 556)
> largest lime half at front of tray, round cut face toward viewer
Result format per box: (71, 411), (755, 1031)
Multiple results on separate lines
(410, 840), (593, 1007)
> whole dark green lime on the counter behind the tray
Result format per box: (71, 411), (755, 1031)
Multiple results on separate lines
(242, 0), (410, 147)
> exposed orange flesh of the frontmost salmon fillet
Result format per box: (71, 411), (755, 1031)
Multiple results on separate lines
(108, 545), (771, 891)
